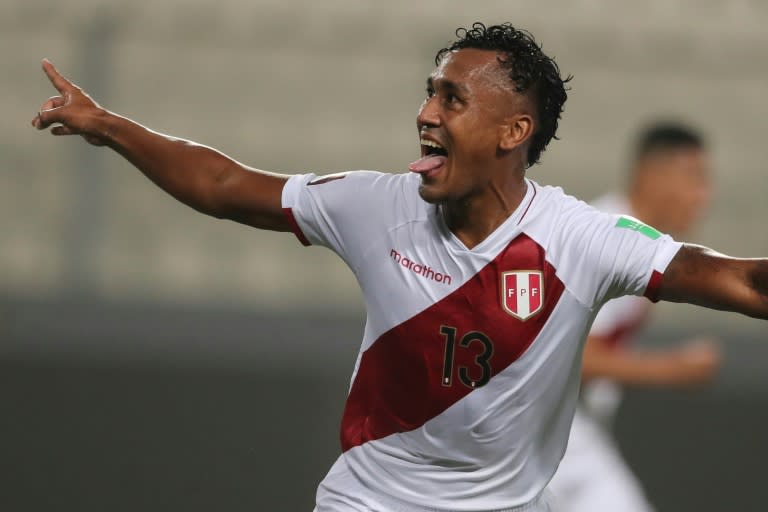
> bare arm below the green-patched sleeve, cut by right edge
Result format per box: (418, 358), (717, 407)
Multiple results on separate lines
(658, 244), (768, 319)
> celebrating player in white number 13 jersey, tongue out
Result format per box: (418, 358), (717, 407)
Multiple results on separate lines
(32, 24), (768, 512)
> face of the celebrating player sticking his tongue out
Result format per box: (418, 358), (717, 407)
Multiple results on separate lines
(410, 49), (532, 203)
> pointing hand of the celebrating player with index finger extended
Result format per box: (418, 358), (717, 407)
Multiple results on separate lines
(32, 59), (109, 146)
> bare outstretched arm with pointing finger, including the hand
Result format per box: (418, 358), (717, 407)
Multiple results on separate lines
(32, 60), (290, 231)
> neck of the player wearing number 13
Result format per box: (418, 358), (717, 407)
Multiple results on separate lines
(440, 174), (528, 249)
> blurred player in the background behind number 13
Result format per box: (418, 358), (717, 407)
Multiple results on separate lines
(549, 122), (720, 512)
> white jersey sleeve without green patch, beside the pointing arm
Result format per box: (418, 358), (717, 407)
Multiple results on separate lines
(282, 171), (399, 270)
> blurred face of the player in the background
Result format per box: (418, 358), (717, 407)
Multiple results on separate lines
(643, 148), (712, 236)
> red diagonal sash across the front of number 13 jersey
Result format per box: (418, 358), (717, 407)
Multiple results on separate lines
(341, 235), (564, 451)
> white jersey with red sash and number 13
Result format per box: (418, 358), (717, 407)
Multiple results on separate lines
(282, 171), (679, 511)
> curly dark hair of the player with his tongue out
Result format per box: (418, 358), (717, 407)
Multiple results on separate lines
(435, 22), (573, 167)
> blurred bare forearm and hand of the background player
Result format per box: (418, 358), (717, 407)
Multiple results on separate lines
(582, 335), (721, 386)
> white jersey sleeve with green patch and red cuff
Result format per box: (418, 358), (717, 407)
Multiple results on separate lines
(556, 196), (682, 308)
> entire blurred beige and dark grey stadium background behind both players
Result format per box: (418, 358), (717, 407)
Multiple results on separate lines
(0, 0), (768, 511)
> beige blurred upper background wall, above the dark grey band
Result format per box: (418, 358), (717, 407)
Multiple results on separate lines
(0, 0), (768, 330)
